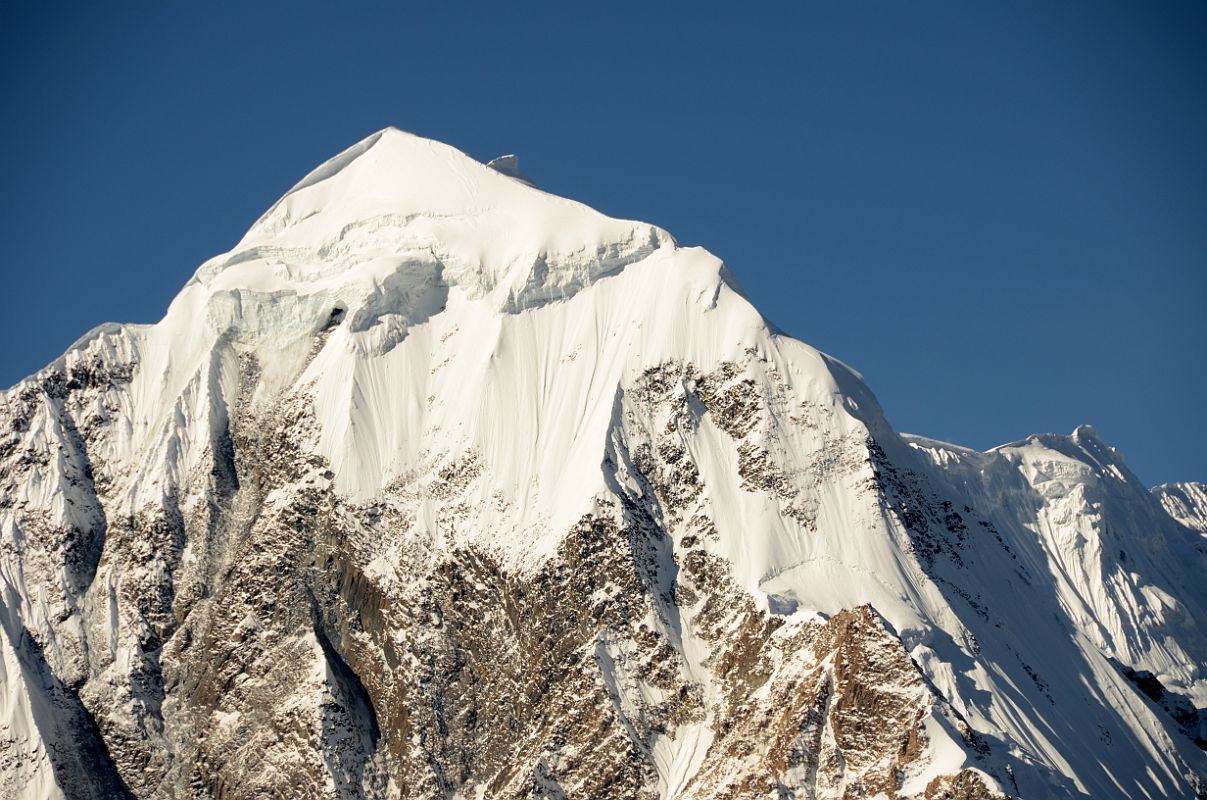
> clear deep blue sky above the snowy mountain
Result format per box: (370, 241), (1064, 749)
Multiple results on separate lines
(0, 0), (1207, 484)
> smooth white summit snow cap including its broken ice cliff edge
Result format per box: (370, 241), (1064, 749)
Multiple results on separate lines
(182, 128), (675, 351)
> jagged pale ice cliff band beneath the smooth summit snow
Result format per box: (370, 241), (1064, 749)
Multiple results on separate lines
(184, 218), (667, 352)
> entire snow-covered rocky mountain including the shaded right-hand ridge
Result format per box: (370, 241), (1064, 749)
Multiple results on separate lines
(0, 129), (1207, 798)
